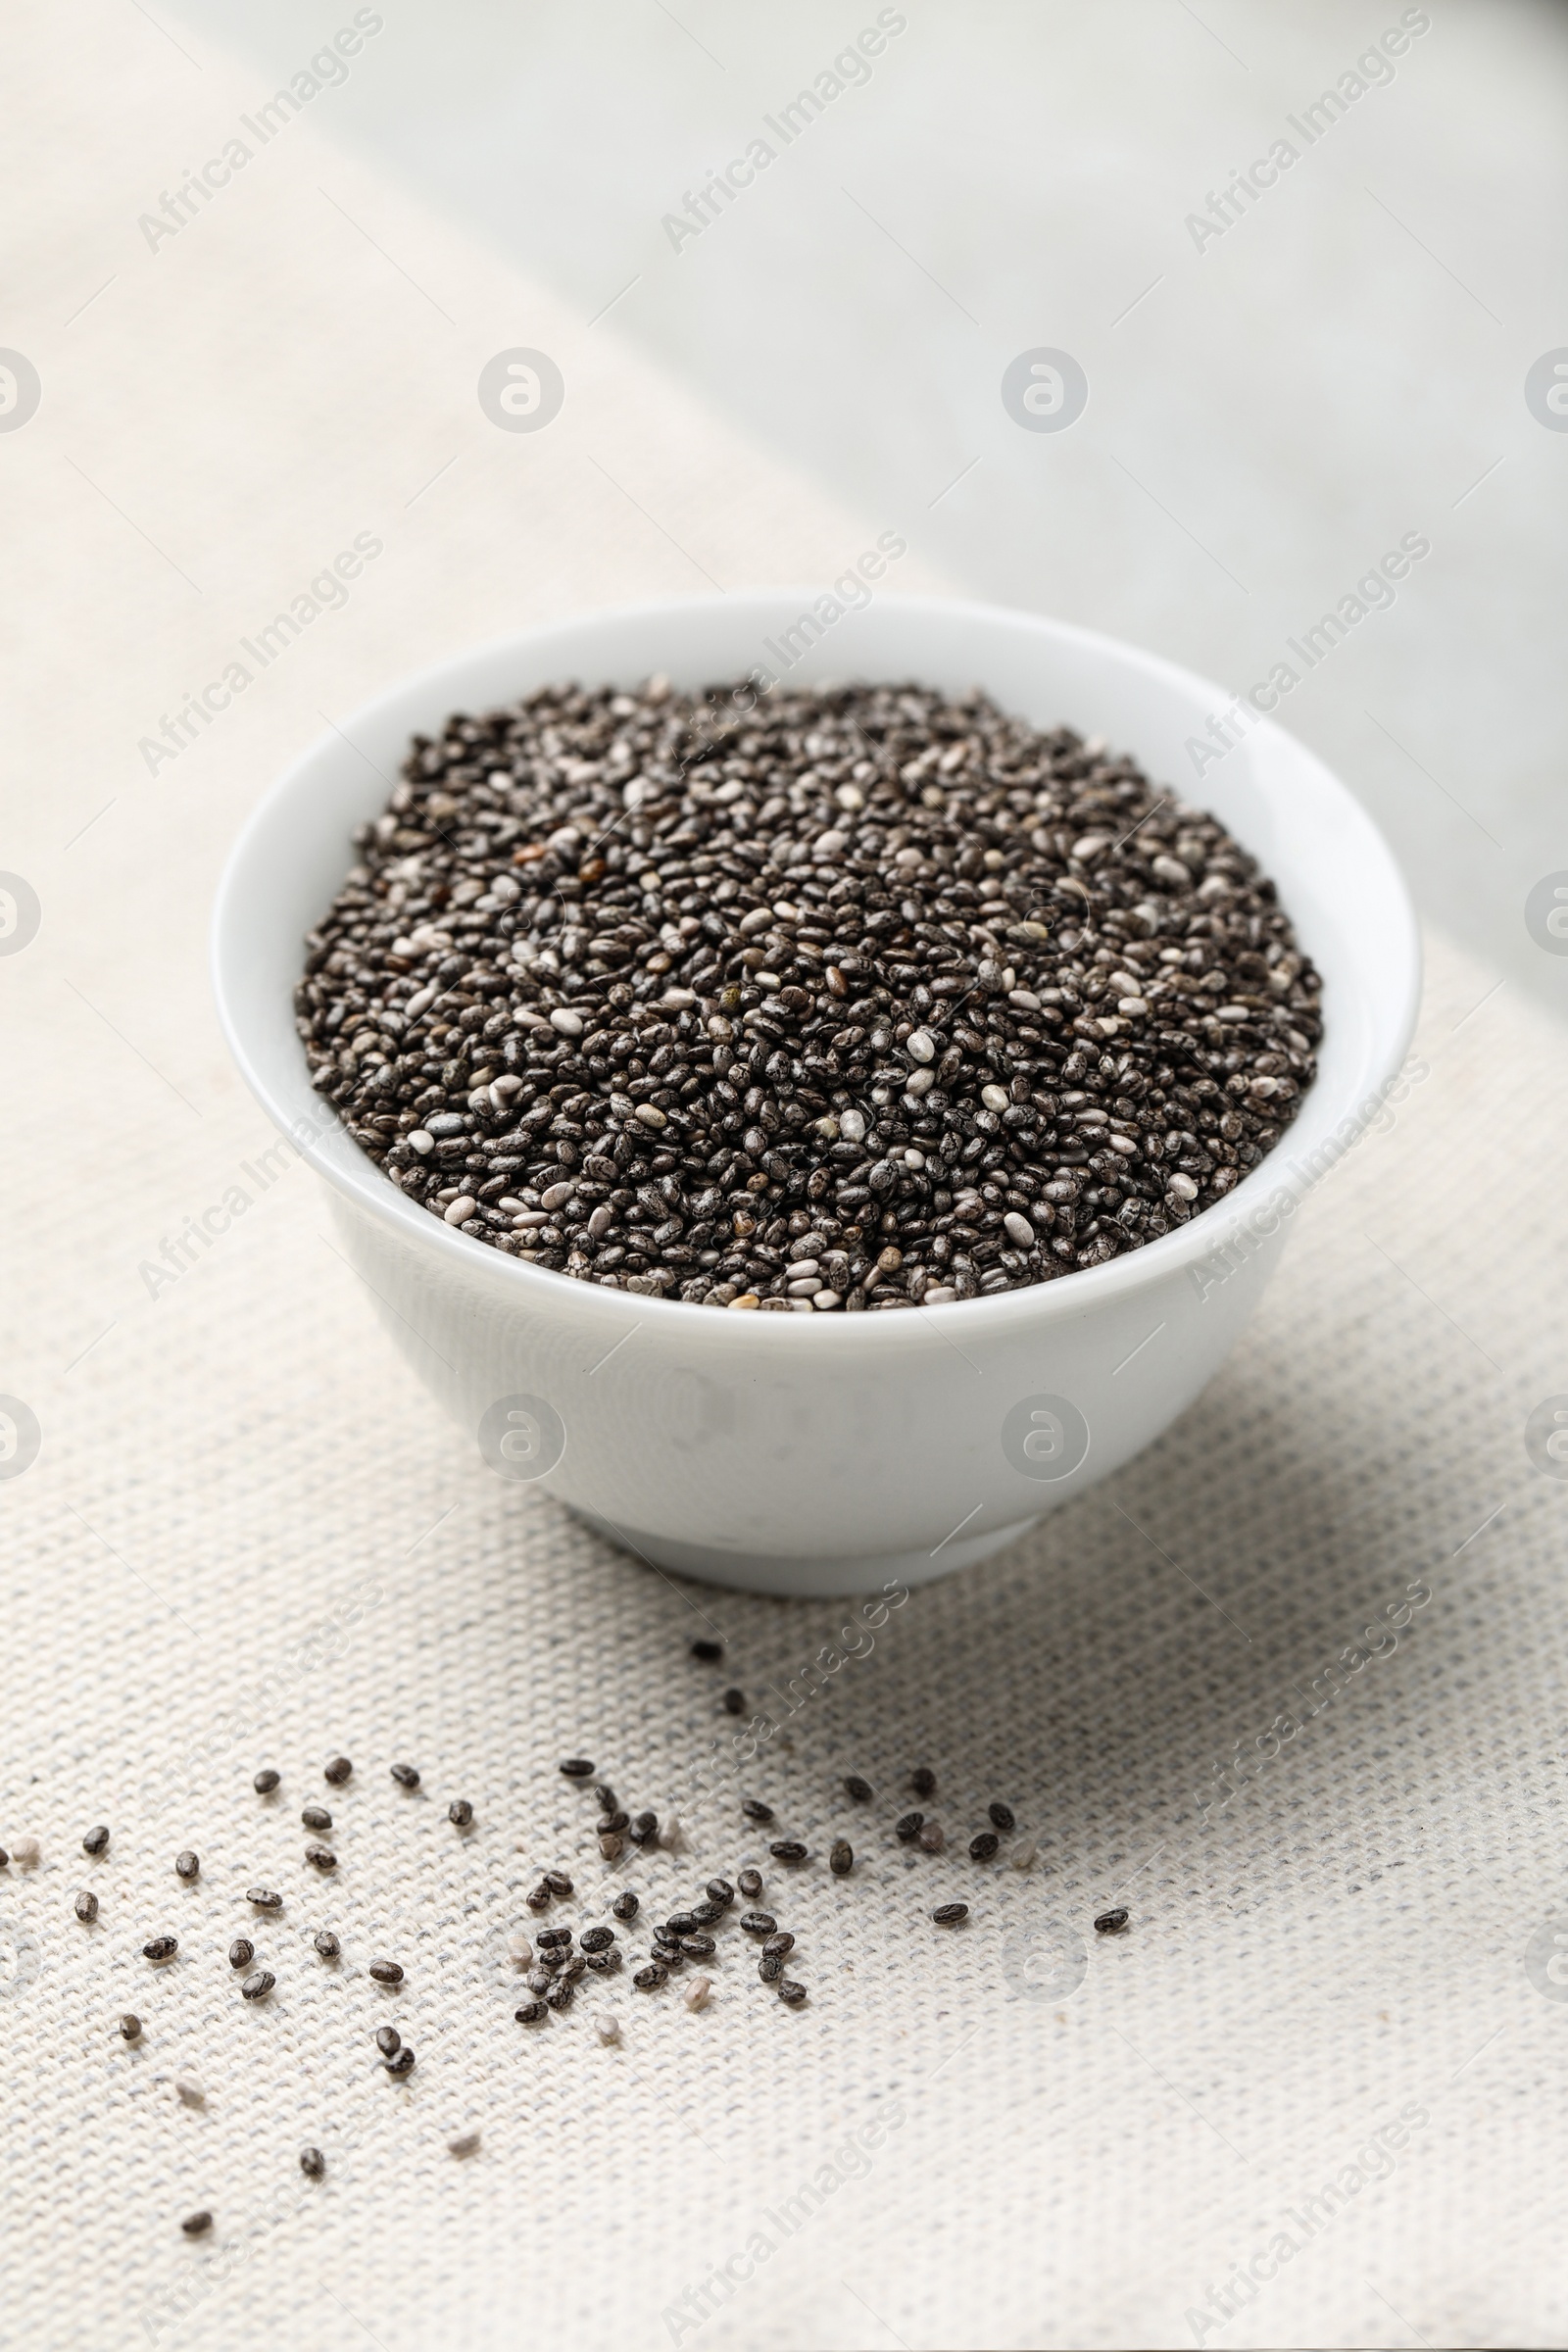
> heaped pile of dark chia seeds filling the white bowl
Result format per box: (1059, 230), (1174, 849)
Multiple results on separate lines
(296, 677), (1321, 1312)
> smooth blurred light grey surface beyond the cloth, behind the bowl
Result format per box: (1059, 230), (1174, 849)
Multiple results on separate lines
(177, 0), (1568, 1011)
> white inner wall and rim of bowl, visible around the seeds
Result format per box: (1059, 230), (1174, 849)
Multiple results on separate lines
(214, 590), (1420, 1289)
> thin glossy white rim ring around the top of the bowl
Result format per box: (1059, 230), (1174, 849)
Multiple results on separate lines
(212, 583), (1422, 1350)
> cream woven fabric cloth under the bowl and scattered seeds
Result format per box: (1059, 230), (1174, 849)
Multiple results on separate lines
(0, 12), (1568, 2352)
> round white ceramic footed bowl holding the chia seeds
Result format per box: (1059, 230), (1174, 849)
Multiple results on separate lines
(214, 590), (1420, 1594)
